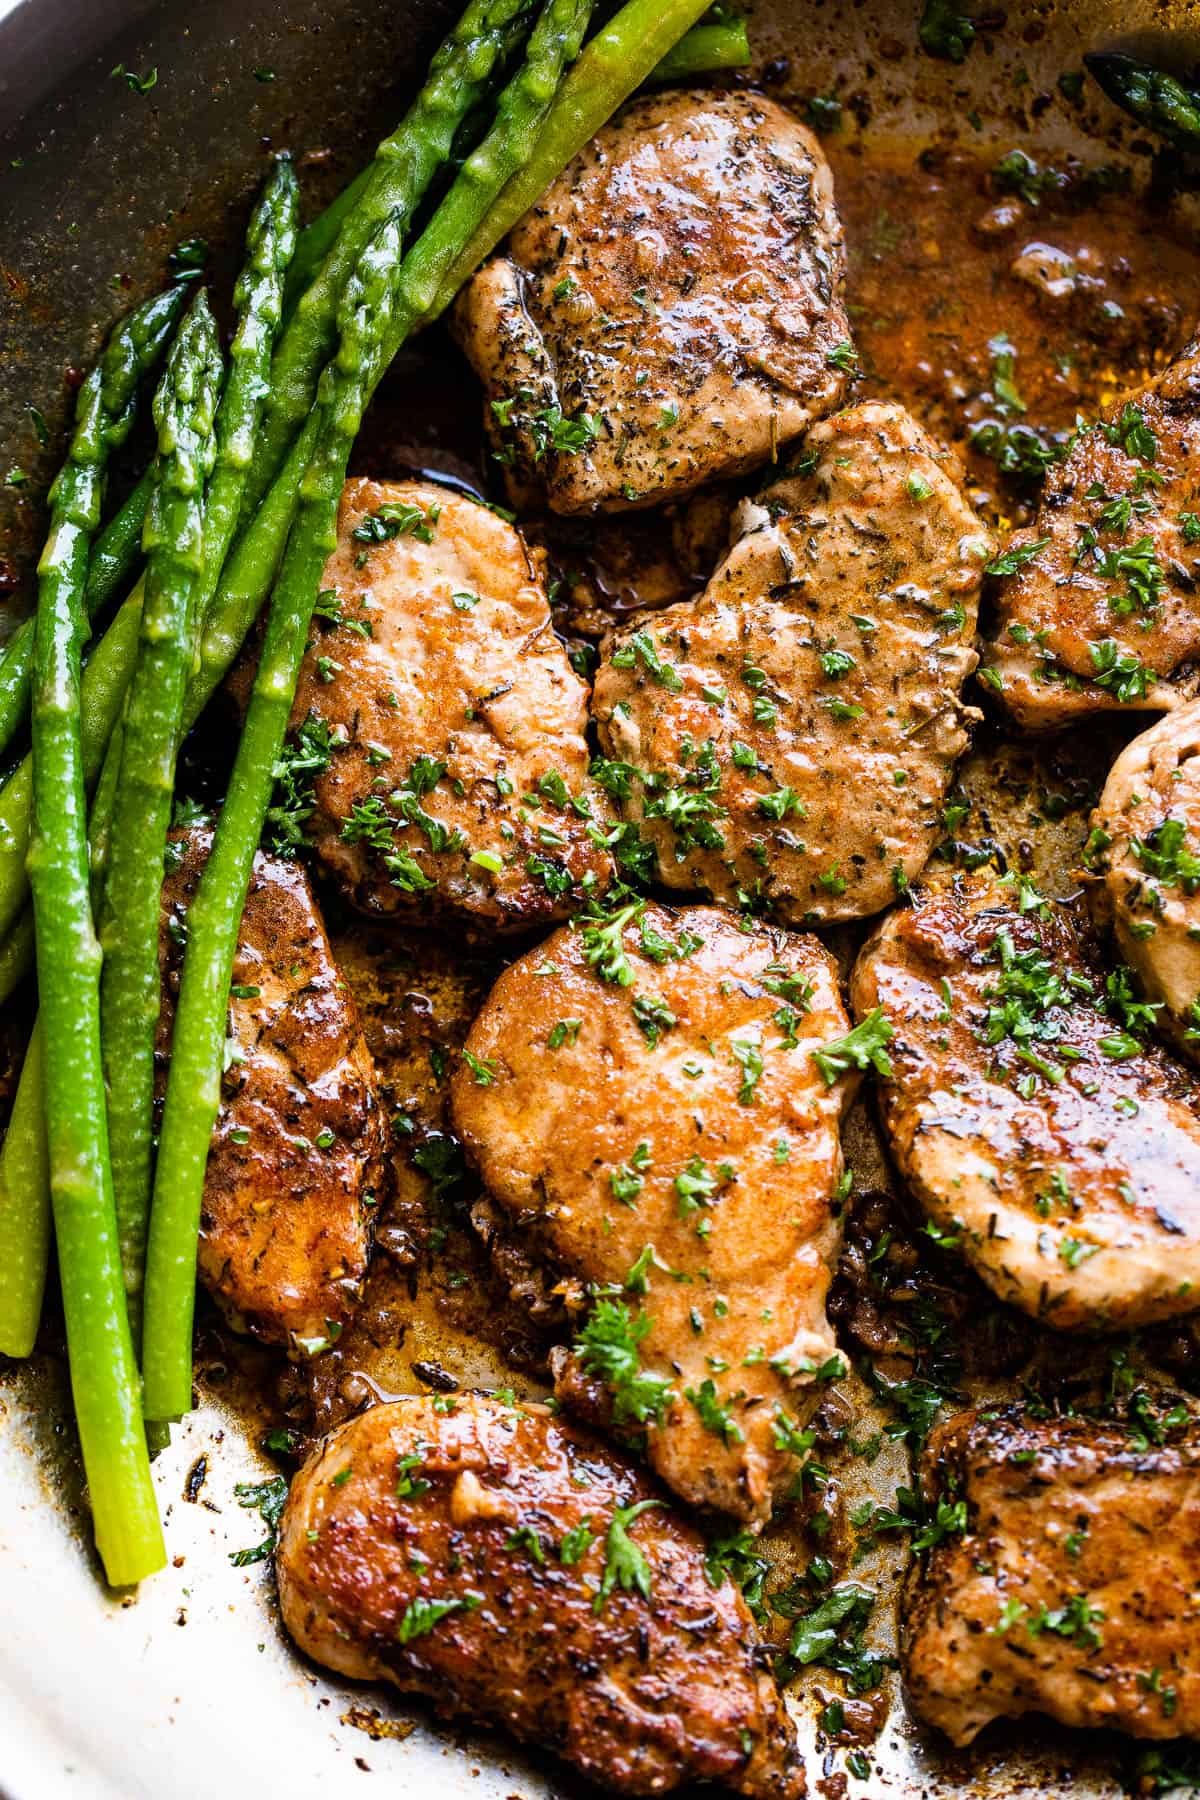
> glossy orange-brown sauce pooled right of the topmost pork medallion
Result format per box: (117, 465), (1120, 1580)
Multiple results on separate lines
(824, 135), (1200, 518)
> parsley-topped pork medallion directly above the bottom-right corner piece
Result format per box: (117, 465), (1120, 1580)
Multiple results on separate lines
(851, 877), (1200, 1330)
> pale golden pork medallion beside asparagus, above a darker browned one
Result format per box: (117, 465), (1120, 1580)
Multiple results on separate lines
(291, 481), (610, 932)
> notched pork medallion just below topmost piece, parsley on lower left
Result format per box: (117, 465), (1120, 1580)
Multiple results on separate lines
(594, 403), (990, 923)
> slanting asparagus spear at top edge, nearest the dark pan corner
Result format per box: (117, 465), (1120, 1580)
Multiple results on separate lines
(248, 0), (531, 518)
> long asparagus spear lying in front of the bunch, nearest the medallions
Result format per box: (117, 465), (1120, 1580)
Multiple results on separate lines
(142, 214), (403, 1420)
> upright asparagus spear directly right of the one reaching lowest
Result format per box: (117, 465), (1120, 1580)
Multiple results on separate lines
(101, 290), (223, 1343)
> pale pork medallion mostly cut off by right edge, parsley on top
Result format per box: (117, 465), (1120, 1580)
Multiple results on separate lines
(1088, 702), (1200, 1058)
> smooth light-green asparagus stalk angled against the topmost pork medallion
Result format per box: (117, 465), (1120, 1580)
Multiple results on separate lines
(425, 0), (711, 320)
